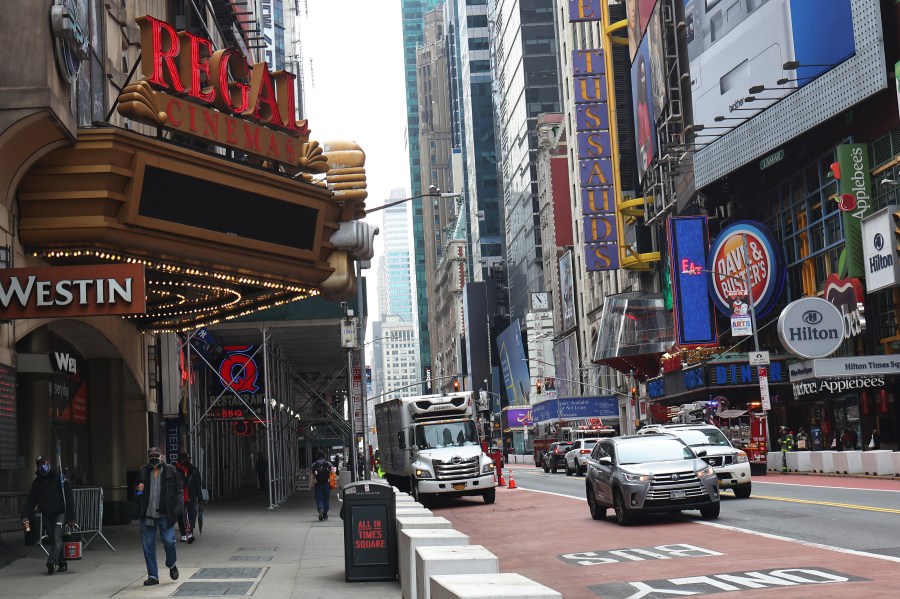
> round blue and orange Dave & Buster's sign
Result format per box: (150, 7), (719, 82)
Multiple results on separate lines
(707, 221), (786, 317)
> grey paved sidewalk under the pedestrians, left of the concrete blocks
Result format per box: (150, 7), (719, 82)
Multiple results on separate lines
(0, 490), (400, 599)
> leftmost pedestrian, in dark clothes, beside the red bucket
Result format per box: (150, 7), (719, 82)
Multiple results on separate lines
(22, 456), (75, 574)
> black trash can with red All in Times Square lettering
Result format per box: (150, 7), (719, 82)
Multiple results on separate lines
(341, 480), (399, 582)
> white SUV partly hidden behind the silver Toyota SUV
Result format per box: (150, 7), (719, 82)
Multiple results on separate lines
(638, 424), (752, 499)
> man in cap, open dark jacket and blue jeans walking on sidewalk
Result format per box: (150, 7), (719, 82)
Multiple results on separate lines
(135, 447), (184, 586)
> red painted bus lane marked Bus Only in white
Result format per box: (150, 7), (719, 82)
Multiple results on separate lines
(435, 488), (900, 599)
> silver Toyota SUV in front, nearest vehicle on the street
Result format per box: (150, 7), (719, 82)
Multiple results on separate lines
(585, 433), (719, 526)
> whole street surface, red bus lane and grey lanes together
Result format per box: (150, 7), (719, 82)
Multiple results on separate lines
(433, 466), (900, 598)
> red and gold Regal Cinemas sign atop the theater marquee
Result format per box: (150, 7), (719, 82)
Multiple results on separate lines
(118, 16), (316, 170)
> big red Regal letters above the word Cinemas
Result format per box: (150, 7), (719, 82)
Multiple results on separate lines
(136, 16), (307, 135)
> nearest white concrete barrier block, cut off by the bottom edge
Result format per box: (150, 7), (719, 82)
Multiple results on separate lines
(431, 572), (562, 599)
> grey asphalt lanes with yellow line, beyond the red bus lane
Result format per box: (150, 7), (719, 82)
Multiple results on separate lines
(506, 468), (900, 557)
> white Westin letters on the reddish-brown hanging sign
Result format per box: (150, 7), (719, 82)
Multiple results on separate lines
(0, 275), (133, 308)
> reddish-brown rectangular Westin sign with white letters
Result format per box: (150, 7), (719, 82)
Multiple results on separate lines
(0, 264), (147, 320)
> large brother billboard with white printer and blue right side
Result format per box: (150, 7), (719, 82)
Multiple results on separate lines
(684, 0), (855, 131)
